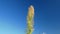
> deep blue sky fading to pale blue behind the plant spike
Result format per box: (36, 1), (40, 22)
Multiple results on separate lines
(0, 0), (60, 34)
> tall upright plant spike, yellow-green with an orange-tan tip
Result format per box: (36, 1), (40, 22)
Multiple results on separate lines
(27, 5), (34, 34)
